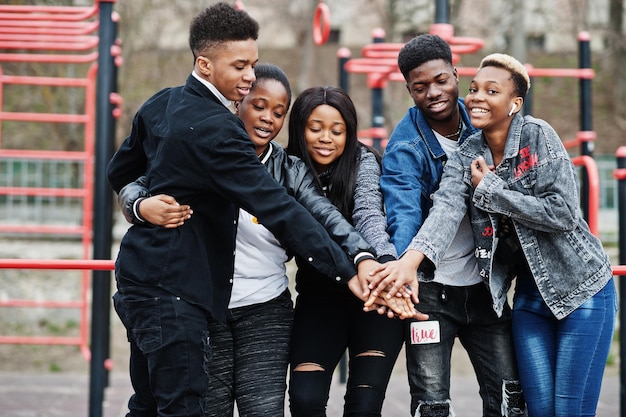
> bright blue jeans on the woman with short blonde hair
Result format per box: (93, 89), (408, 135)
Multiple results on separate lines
(513, 274), (616, 417)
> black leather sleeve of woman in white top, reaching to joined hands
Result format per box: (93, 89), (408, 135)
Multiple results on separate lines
(285, 156), (376, 260)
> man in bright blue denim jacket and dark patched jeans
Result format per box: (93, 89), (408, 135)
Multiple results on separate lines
(381, 35), (524, 417)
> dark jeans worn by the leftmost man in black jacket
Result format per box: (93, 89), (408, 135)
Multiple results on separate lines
(113, 287), (210, 417)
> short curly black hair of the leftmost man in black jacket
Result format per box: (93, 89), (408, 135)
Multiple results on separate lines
(189, 2), (259, 61)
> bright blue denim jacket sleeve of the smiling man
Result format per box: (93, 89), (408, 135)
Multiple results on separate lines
(380, 138), (427, 254)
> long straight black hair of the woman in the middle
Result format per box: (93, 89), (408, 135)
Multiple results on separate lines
(287, 87), (378, 220)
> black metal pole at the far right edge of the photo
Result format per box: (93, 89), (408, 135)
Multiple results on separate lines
(616, 146), (626, 417)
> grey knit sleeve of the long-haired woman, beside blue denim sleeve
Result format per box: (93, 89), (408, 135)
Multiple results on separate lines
(352, 149), (397, 258)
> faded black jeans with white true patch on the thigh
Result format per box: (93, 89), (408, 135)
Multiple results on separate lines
(406, 282), (524, 417)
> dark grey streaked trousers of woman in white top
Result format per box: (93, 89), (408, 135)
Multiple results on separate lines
(207, 290), (293, 417)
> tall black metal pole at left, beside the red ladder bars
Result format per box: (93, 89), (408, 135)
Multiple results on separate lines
(89, 0), (116, 417)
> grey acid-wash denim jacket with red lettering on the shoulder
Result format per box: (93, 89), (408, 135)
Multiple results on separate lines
(409, 114), (612, 319)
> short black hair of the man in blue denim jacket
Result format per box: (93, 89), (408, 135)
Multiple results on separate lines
(398, 33), (452, 80)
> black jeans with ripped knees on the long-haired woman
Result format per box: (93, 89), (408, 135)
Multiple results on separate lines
(289, 293), (404, 417)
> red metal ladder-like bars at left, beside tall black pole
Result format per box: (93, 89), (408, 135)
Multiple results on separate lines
(0, 0), (111, 359)
